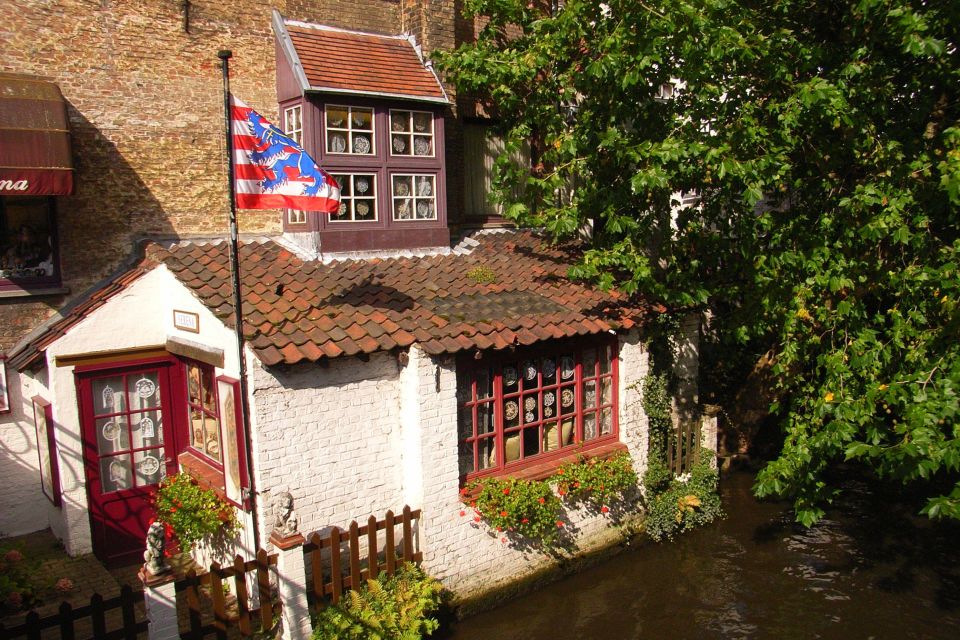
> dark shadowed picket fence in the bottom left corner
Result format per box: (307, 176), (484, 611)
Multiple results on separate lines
(0, 585), (147, 640)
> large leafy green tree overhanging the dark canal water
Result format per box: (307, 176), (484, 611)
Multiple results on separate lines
(439, 0), (960, 524)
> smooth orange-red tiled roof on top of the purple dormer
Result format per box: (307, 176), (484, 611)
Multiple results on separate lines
(286, 23), (446, 101)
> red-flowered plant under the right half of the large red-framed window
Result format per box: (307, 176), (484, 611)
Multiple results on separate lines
(555, 453), (637, 513)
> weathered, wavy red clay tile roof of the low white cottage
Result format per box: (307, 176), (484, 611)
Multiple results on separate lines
(148, 231), (644, 365)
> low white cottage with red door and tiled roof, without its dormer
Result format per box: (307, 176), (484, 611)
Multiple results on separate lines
(3, 230), (695, 596)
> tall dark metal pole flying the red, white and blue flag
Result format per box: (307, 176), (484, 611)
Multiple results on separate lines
(217, 49), (260, 553)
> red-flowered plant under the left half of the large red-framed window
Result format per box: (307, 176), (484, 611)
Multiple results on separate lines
(463, 478), (563, 547)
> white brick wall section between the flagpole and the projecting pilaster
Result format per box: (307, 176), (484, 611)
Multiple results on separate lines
(251, 354), (404, 546)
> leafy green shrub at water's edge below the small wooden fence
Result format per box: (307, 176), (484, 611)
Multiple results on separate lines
(644, 462), (723, 542)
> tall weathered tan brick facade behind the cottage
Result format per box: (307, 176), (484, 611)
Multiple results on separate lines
(0, 0), (462, 352)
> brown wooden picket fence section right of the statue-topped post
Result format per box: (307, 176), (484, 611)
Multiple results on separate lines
(303, 506), (423, 609)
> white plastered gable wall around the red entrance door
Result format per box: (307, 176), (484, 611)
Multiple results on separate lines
(33, 265), (249, 555)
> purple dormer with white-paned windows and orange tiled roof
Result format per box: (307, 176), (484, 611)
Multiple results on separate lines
(273, 12), (450, 255)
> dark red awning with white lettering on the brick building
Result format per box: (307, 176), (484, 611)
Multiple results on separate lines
(0, 73), (73, 196)
